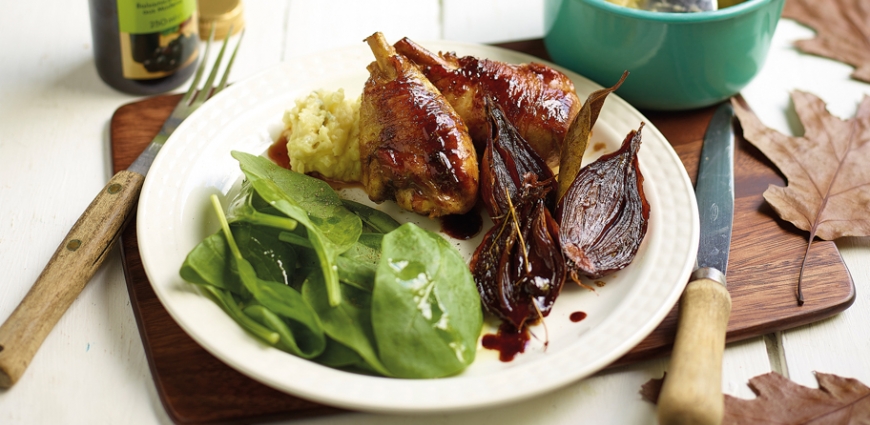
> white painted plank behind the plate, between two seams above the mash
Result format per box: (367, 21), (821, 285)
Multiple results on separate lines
(284, 0), (441, 60)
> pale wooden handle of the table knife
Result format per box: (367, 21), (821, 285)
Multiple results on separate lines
(658, 276), (731, 425)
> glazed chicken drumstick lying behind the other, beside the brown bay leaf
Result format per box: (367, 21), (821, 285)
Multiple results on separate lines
(394, 37), (582, 167)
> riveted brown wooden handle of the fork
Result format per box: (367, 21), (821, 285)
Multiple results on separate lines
(0, 171), (145, 388)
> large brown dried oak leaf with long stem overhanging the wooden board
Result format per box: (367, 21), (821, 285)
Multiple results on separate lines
(731, 91), (870, 305)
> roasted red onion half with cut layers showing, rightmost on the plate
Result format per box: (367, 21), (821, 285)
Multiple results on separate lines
(555, 123), (650, 281)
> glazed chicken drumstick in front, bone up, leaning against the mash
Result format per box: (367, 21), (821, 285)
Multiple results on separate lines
(360, 33), (478, 217)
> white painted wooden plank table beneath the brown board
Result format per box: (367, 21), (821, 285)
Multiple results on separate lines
(0, 0), (870, 425)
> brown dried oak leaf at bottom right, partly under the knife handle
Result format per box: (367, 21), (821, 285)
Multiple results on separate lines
(640, 372), (870, 425)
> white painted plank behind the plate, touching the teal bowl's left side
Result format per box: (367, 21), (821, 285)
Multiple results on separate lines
(443, 0), (544, 43)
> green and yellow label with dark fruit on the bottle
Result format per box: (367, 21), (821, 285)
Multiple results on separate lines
(118, 0), (199, 80)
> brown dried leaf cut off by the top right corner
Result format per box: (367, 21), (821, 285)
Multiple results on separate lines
(782, 0), (870, 83)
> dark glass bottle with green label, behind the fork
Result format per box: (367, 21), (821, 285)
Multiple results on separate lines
(89, 0), (199, 95)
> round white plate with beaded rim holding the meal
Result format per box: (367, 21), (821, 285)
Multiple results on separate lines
(137, 42), (698, 412)
